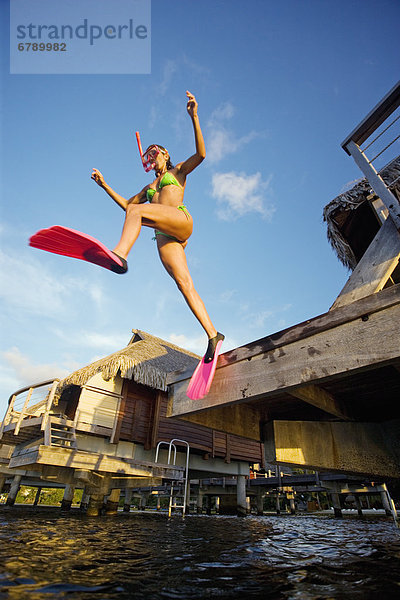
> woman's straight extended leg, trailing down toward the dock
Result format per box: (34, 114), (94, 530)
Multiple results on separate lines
(157, 236), (217, 338)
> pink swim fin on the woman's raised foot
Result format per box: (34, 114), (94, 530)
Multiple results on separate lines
(29, 225), (128, 274)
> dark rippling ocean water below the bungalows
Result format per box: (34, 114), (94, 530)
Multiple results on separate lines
(0, 507), (400, 600)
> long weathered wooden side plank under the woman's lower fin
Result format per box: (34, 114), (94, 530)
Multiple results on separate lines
(170, 300), (400, 416)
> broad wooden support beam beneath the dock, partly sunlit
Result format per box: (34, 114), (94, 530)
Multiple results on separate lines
(264, 421), (400, 478)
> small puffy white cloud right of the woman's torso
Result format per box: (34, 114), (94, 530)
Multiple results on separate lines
(211, 171), (275, 221)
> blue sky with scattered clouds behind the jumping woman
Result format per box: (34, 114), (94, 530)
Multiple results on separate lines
(0, 0), (400, 412)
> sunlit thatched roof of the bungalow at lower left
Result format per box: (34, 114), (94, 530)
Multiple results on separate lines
(57, 329), (200, 396)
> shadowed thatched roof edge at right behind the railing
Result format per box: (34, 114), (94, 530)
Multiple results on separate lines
(323, 156), (400, 269)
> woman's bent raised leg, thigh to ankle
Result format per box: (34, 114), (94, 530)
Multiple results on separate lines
(113, 204), (193, 258)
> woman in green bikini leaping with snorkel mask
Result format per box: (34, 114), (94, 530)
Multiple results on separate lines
(92, 92), (224, 362)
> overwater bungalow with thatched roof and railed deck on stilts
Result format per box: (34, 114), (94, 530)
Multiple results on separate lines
(0, 330), (264, 514)
